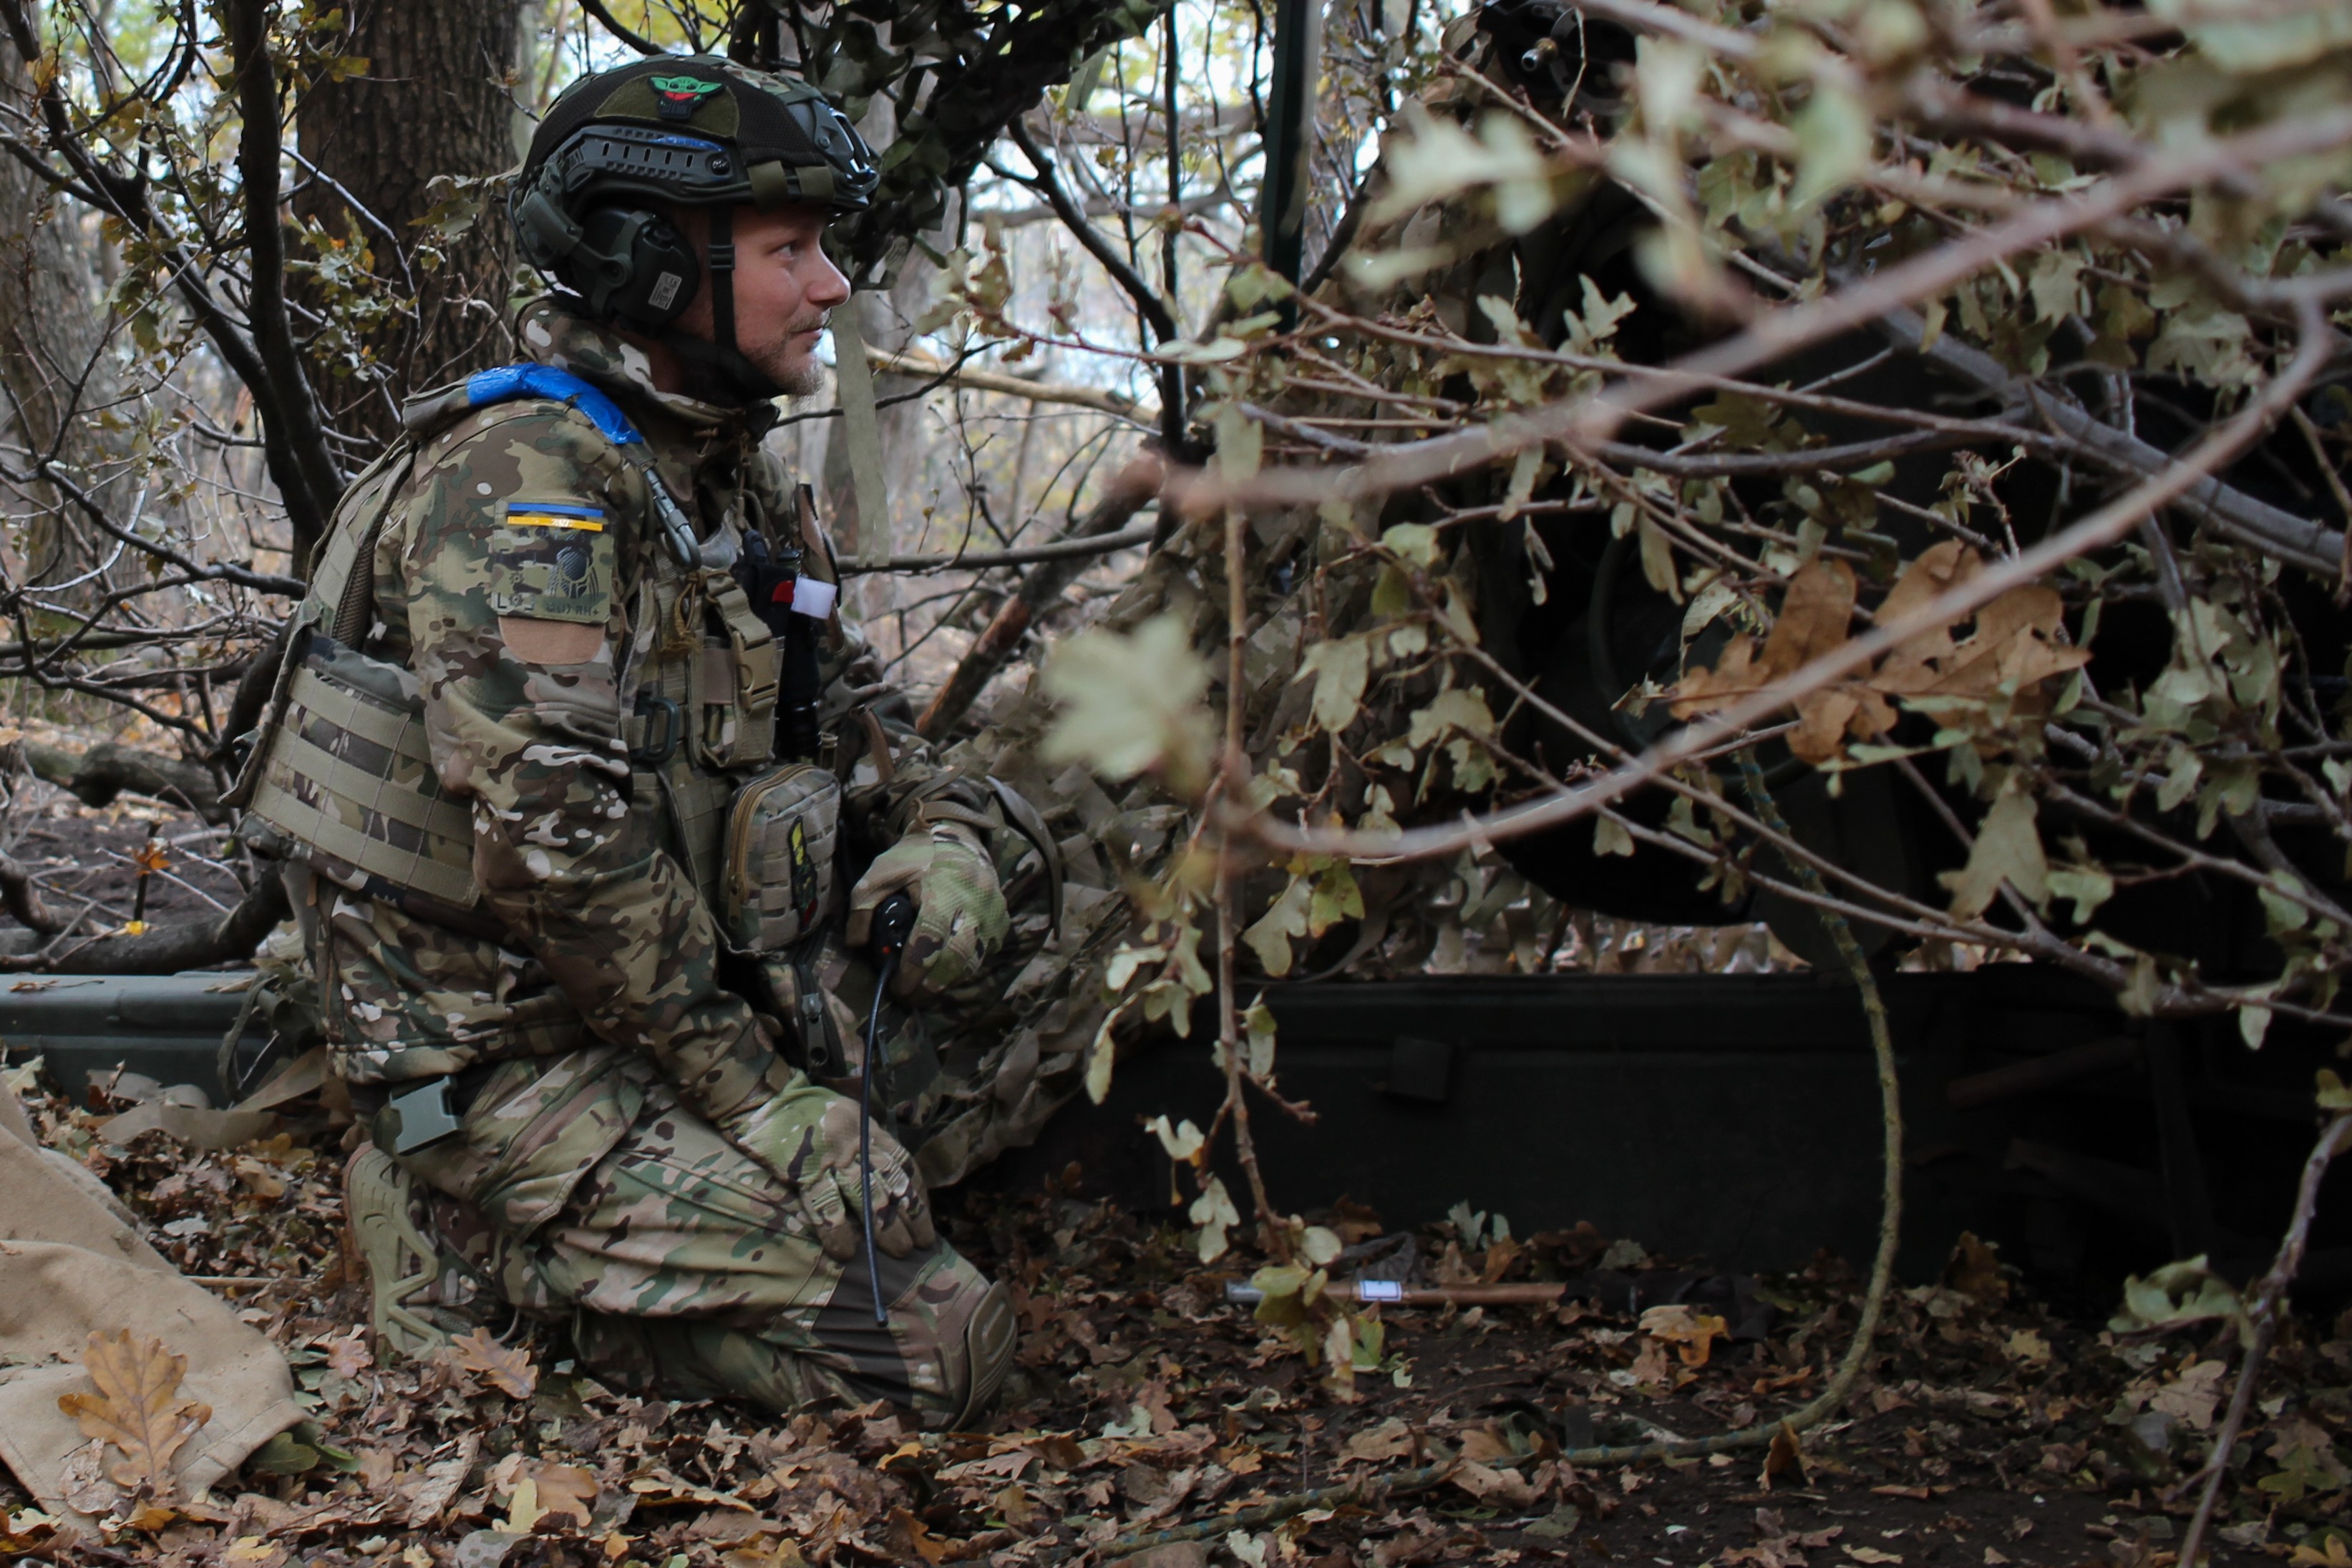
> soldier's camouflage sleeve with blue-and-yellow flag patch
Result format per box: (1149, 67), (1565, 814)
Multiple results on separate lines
(388, 404), (800, 1126)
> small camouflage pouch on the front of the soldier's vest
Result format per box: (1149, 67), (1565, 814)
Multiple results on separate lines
(720, 761), (842, 955)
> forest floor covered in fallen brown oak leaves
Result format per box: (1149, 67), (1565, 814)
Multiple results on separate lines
(0, 1070), (2352, 1568)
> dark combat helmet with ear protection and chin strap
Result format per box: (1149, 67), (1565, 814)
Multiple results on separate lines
(508, 54), (882, 397)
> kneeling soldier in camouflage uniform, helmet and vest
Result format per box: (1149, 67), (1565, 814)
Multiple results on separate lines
(238, 57), (1021, 1427)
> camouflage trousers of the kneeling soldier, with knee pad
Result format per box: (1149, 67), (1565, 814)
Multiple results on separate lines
(402, 1053), (1002, 1427)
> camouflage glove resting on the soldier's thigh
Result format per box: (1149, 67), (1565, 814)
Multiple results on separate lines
(727, 1084), (938, 1262)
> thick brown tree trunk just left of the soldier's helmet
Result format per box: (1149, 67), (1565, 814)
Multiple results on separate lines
(294, 0), (525, 456)
